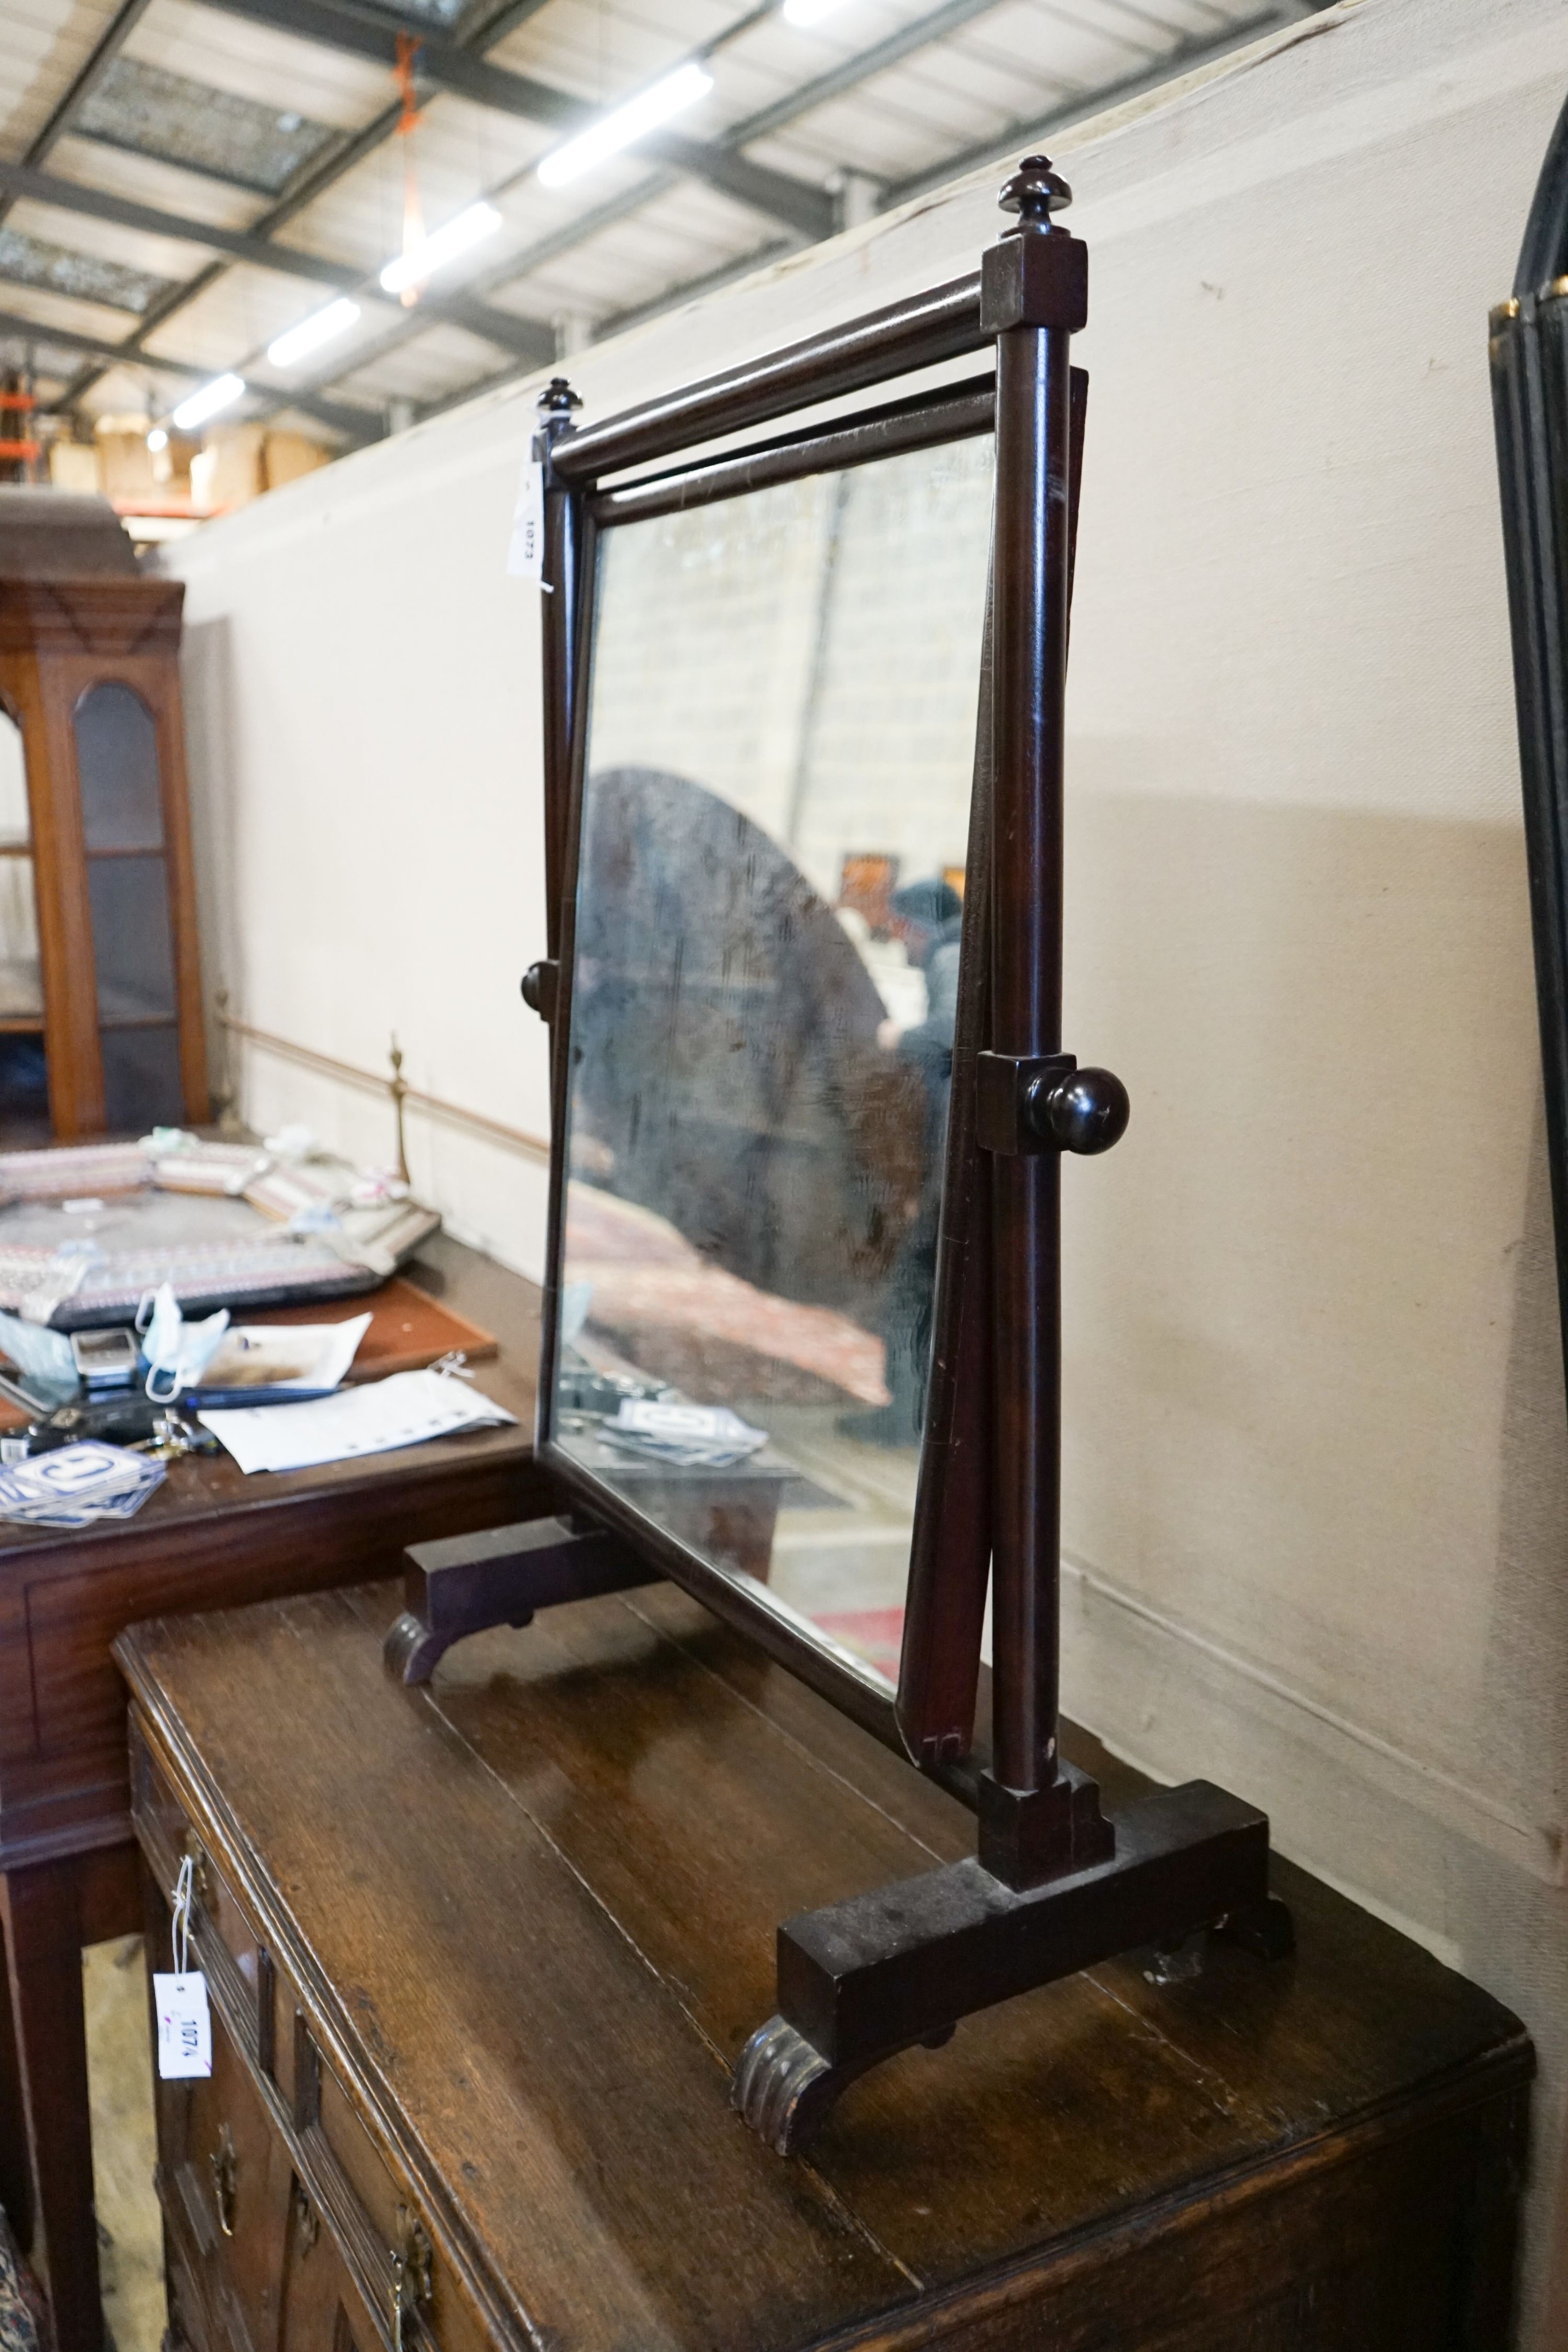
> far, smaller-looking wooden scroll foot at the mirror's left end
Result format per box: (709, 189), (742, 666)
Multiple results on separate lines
(381, 1519), (663, 1684)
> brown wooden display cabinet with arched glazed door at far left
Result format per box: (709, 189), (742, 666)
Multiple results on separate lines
(0, 489), (209, 1141)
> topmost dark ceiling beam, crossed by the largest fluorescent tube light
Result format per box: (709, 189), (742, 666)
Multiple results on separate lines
(207, 0), (832, 238)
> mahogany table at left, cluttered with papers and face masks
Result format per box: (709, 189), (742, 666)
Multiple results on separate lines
(0, 1237), (548, 2352)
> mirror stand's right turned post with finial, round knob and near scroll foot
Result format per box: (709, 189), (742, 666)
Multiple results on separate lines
(733, 157), (1291, 2152)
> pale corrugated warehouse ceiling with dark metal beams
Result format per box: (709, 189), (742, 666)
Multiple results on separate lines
(0, 0), (1317, 440)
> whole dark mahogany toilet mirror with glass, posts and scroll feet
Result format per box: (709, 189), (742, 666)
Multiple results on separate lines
(388, 157), (1291, 2152)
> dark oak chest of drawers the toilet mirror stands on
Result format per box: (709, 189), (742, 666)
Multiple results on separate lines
(118, 1585), (1530, 2352)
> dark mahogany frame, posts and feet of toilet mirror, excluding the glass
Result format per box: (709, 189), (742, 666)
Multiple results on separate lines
(388, 155), (1293, 2154)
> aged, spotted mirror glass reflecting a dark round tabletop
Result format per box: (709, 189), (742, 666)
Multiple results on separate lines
(555, 438), (992, 1680)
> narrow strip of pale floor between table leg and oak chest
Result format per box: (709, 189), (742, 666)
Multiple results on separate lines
(82, 1936), (169, 2352)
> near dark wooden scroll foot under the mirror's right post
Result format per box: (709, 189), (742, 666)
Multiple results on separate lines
(731, 1781), (1293, 2154)
